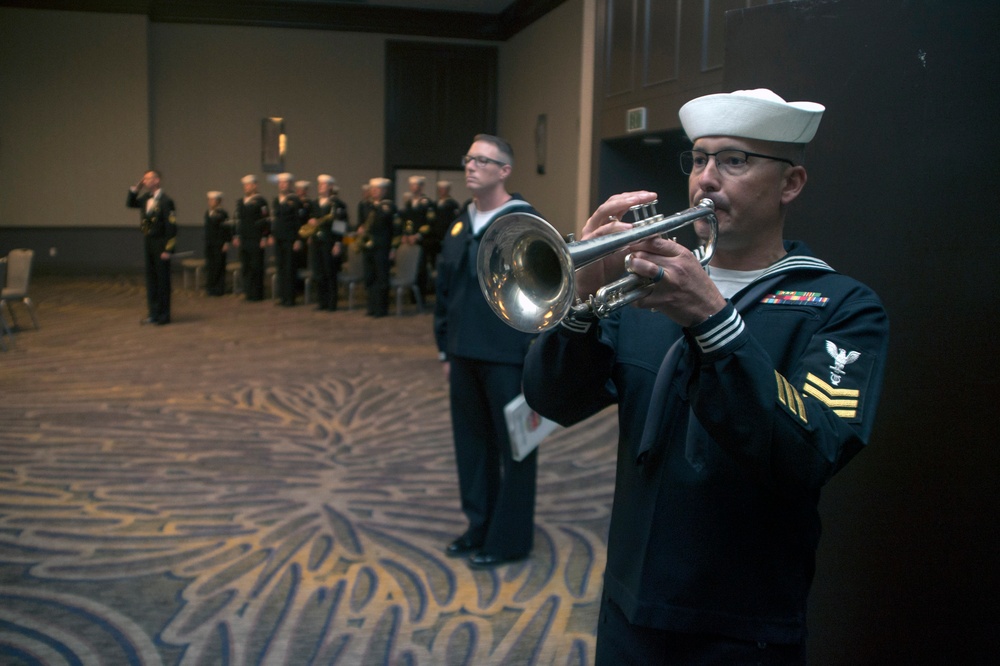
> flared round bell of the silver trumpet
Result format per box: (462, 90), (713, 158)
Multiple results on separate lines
(477, 213), (576, 333)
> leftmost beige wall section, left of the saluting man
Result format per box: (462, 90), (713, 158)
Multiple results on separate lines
(0, 8), (149, 227)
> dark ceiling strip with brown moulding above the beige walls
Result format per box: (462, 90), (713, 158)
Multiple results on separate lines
(0, 0), (565, 41)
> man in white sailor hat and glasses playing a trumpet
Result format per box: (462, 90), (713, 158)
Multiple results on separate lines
(524, 90), (888, 666)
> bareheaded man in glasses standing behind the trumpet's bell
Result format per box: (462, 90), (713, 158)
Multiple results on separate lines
(434, 134), (538, 568)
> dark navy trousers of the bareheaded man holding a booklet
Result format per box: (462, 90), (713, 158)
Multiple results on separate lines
(449, 357), (538, 557)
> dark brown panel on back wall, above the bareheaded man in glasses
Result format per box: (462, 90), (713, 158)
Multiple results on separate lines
(385, 42), (497, 174)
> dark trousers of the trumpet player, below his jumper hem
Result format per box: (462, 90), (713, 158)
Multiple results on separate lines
(594, 597), (806, 666)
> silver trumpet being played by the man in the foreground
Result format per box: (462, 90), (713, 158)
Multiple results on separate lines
(477, 198), (718, 333)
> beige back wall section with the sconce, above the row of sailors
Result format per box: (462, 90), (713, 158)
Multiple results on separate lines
(146, 24), (385, 225)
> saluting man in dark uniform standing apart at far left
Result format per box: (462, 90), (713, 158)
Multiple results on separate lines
(125, 169), (177, 326)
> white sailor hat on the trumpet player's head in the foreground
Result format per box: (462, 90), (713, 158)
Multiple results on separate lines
(678, 88), (826, 143)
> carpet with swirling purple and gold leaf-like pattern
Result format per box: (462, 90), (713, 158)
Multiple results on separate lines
(0, 276), (616, 665)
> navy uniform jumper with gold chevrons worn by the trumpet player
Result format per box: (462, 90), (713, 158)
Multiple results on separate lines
(523, 243), (888, 643)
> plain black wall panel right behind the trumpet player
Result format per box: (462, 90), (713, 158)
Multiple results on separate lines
(725, 0), (1000, 666)
